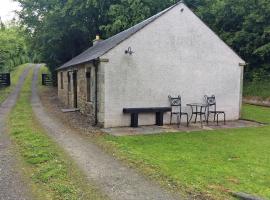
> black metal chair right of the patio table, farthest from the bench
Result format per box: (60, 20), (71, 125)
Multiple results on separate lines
(204, 95), (226, 125)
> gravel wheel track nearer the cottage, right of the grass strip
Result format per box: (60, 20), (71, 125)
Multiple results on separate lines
(32, 66), (182, 200)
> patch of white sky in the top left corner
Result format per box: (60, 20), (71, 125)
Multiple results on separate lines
(0, 0), (20, 22)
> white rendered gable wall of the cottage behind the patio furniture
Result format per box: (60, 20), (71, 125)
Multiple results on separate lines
(101, 4), (244, 127)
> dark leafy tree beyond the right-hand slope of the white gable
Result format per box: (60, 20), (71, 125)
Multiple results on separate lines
(194, 0), (270, 80)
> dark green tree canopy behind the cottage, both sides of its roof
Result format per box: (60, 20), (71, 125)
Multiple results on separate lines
(16, 0), (270, 79)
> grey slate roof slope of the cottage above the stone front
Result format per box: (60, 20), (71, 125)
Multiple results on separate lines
(57, 2), (181, 70)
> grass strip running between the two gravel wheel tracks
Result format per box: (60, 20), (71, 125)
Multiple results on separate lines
(9, 67), (105, 200)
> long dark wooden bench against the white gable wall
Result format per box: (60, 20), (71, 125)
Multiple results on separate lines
(123, 107), (172, 127)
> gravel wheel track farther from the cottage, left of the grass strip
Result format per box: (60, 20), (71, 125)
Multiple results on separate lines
(0, 67), (30, 200)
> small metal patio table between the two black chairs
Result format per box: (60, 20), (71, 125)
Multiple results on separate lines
(187, 103), (208, 125)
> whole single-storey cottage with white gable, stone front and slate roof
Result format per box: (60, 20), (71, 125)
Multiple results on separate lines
(58, 3), (245, 127)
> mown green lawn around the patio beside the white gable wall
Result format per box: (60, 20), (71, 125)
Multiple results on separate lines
(101, 105), (270, 199)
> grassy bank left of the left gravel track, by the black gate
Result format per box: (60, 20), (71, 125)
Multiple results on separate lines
(0, 64), (27, 104)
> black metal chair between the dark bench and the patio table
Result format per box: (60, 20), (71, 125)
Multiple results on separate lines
(168, 95), (189, 127)
